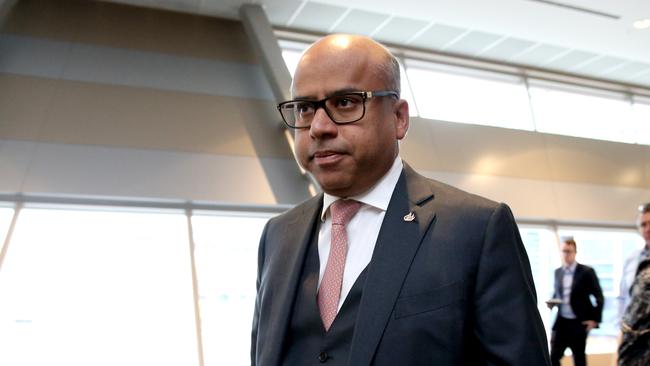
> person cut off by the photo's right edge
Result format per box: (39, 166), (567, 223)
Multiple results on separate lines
(618, 203), (650, 366)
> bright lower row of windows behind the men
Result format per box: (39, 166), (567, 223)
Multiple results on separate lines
(0, 206), (642, 366)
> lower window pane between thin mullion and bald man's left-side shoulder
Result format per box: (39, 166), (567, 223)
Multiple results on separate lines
(192, 216), (268, 366)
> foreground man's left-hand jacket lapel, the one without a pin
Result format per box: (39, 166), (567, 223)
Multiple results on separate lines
(258, 194), (323, 365)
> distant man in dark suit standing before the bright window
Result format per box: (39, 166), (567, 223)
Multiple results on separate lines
(548, 238), (604, 366)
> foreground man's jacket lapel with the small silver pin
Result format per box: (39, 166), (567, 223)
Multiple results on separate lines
(348, 164), (435, 366)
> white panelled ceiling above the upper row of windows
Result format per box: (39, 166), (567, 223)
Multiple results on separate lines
(101, 0), (650, 87)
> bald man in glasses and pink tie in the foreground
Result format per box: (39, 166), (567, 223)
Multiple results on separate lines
(251, 35), (549, 366)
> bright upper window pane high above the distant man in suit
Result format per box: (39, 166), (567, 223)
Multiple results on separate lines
(530, 86), (637, 143)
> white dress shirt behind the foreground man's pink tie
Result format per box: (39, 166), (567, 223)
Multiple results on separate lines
(318, 156), (403, 310)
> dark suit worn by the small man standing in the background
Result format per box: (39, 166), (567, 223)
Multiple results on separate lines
(551, 263), (604, 365)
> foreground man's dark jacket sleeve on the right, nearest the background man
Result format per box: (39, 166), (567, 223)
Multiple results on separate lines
(474, 204), (550, 366)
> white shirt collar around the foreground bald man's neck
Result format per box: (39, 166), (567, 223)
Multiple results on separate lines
(320, 156), (404, 221)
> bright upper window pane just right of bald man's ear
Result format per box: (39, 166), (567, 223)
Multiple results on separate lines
(406, 60), (534, 130)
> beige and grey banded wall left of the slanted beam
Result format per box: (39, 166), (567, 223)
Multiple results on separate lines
(0, 0), (308, 205)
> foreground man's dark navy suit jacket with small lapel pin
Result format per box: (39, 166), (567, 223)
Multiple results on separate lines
(251, 164), (550, 366)
